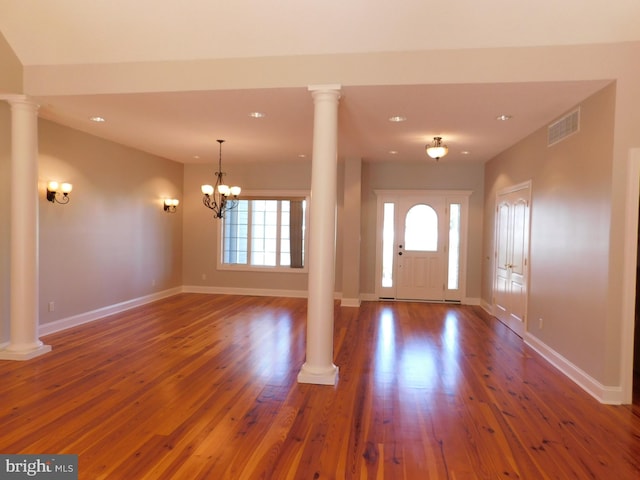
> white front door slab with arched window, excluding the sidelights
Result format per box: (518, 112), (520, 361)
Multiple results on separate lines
(396, 197), (447, 301)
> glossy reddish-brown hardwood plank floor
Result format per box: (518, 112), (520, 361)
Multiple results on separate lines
(0, 294), (640, 480)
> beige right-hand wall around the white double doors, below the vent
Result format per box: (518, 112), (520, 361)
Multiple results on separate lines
(482, 83), (616, 384)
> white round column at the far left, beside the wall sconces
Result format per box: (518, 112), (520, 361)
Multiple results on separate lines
(0, 95), (51, 360)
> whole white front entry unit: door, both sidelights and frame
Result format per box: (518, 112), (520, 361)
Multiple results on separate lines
(376, 190), (471, 302)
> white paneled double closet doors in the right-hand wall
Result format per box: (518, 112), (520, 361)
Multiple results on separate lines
(493, 184), (530, 336)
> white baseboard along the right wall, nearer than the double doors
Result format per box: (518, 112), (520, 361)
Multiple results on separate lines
(524, 332), (624, 405)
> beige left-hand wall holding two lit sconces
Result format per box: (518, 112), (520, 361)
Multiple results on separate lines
(38, 120), (183, 324)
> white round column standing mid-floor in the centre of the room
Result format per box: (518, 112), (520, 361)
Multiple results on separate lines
(298, 85), (340, 385)
